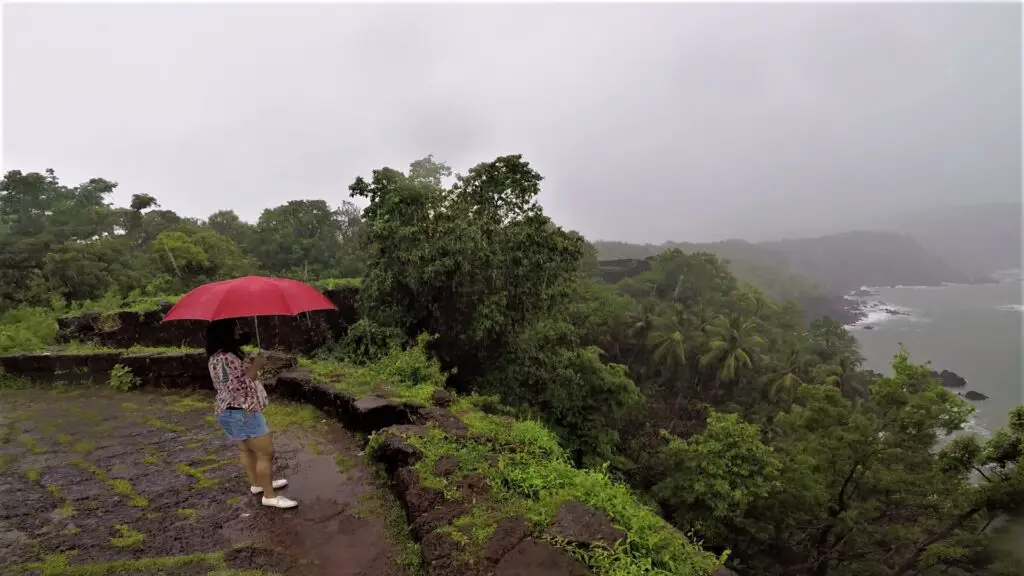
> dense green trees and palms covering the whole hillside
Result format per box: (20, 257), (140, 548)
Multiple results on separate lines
(6, 156), (1024, 576)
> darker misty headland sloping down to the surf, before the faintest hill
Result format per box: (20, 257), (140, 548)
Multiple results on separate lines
(758, 232), (972, 293)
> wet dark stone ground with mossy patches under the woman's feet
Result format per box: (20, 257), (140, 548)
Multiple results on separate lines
(0, 387), (418, 576)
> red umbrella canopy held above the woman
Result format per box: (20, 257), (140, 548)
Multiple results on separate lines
(164, 276), (337, 322)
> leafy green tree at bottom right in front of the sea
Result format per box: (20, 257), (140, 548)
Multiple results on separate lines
(720, 352), (1024, 576)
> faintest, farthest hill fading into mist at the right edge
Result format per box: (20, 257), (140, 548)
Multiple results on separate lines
(863, 202), (1024, 280)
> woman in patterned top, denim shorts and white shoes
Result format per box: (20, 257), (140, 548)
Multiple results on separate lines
(206, 320), (299, 508)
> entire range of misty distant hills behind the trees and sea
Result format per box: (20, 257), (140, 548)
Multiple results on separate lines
(595, 203), (1021, 297)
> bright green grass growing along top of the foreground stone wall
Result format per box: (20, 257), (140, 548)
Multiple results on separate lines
(368, 406), (724, 576)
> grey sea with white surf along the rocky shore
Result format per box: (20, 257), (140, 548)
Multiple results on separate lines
(847, 271), (1024, 437)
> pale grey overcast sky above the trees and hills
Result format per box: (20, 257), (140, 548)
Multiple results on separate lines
(3, 4), (1021, 242)
